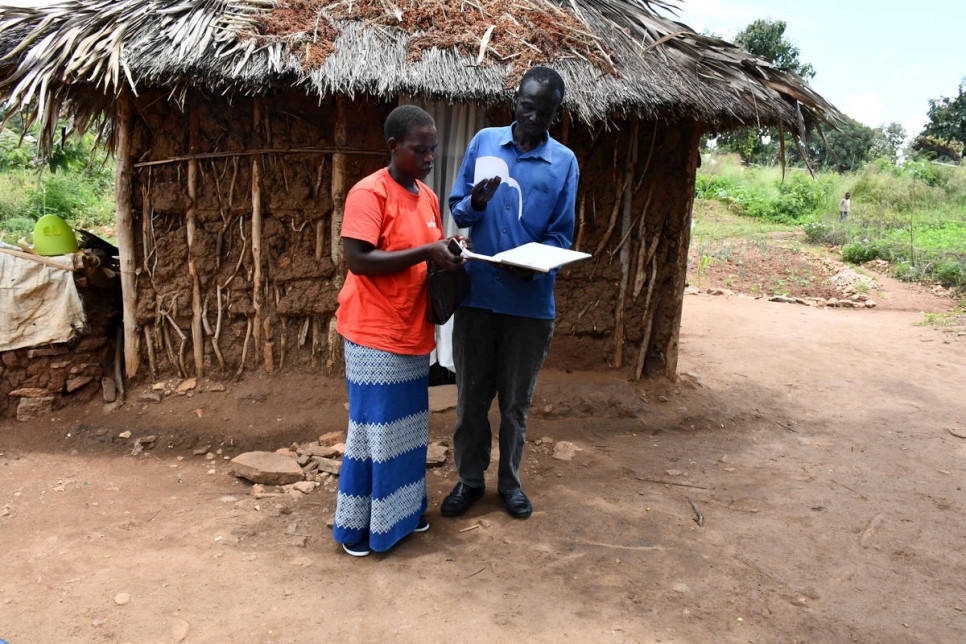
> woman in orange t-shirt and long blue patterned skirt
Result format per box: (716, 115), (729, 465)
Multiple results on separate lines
(333, 105), (466, 557)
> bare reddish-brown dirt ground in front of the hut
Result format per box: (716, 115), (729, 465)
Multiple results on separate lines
(0, 253), (966, 644)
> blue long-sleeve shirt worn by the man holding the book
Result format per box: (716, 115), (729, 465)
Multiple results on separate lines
(449, 123), (580, 320)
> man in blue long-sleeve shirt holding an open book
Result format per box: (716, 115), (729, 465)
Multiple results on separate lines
(440, 67), (579, 519)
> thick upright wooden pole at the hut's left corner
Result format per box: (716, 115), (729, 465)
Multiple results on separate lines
(114, 91), (141, 378)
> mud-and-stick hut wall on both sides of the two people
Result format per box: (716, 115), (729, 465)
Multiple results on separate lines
(131, 92), (699, 377)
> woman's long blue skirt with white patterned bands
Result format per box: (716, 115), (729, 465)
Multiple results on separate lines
(332, 340), (429, 552)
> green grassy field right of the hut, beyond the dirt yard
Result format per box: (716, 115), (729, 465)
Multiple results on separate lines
(695, 157), (966, 288)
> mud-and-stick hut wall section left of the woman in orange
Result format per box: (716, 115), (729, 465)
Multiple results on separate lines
(131, 87), (391, 377)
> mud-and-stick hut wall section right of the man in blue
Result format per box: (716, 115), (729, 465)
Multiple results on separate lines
(550, 119), (700, 377)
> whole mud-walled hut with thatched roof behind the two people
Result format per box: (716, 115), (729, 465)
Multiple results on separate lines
(0, 0), (836, 377)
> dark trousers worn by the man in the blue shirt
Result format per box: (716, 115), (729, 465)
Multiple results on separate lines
(453, 308), (553, 494)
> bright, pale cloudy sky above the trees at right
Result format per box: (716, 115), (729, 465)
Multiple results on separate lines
(662, 0), (966, 137)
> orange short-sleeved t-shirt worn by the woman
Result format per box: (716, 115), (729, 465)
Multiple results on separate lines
(336, 168), (443, 355)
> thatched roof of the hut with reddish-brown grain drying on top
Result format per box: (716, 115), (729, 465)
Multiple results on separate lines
(0, 0), (837, 152)
